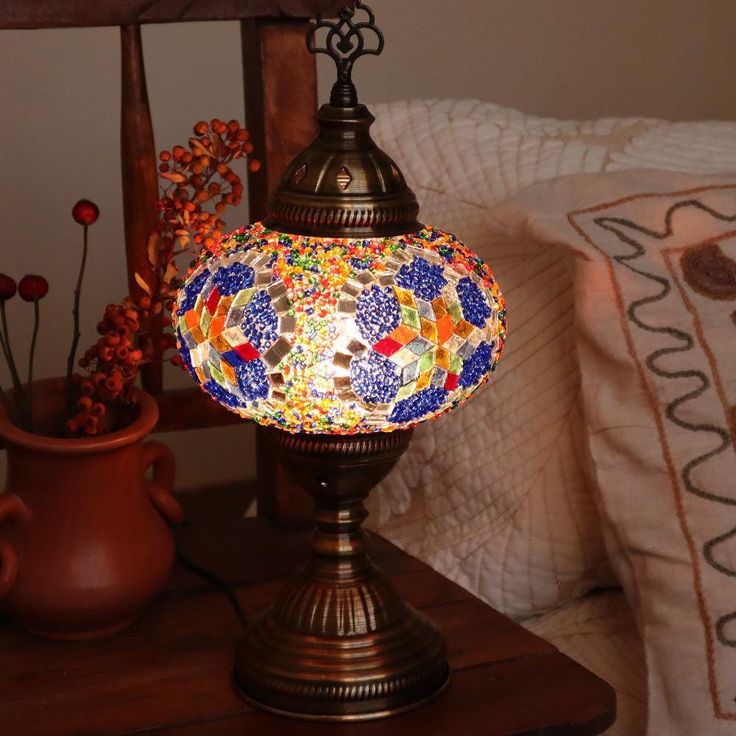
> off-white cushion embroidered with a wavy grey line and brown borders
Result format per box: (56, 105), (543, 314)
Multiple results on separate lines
(484, 167), (736, 736)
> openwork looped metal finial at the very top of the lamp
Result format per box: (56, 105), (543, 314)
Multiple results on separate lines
(307, 0), (383, 107)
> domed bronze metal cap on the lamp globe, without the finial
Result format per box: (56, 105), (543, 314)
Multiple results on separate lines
(265, 105), (421, 238)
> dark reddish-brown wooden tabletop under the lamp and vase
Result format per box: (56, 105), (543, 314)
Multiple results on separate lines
(0, 494), (616, 736)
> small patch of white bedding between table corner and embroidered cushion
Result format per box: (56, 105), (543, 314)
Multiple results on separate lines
(523, 591), (647, 736)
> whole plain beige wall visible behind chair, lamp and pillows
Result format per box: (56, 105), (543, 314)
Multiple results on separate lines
(0, 0), (736, 486)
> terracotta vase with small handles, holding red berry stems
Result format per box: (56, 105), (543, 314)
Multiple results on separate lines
(0, 379), (182, 639)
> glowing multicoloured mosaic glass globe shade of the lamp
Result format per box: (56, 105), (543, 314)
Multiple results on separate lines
(174, 223), (506, 434)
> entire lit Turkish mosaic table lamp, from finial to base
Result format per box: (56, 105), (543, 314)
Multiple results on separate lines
(174, 0), (506, 720)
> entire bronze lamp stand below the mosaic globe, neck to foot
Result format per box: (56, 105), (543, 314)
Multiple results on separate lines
(234, 430), (449, 721)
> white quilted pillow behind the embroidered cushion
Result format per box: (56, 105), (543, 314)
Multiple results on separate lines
(370, 100), (736, 619)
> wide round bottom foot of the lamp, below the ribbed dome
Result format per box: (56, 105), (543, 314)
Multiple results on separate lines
(234, 606), (449, 721)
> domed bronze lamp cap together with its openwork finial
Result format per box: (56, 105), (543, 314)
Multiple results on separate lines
(265, 0), (421, 238)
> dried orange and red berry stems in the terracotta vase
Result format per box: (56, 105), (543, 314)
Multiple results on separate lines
(0, 118), (260, 437)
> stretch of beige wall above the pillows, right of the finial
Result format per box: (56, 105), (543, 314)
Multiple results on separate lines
(348, 0), (736, 120)
